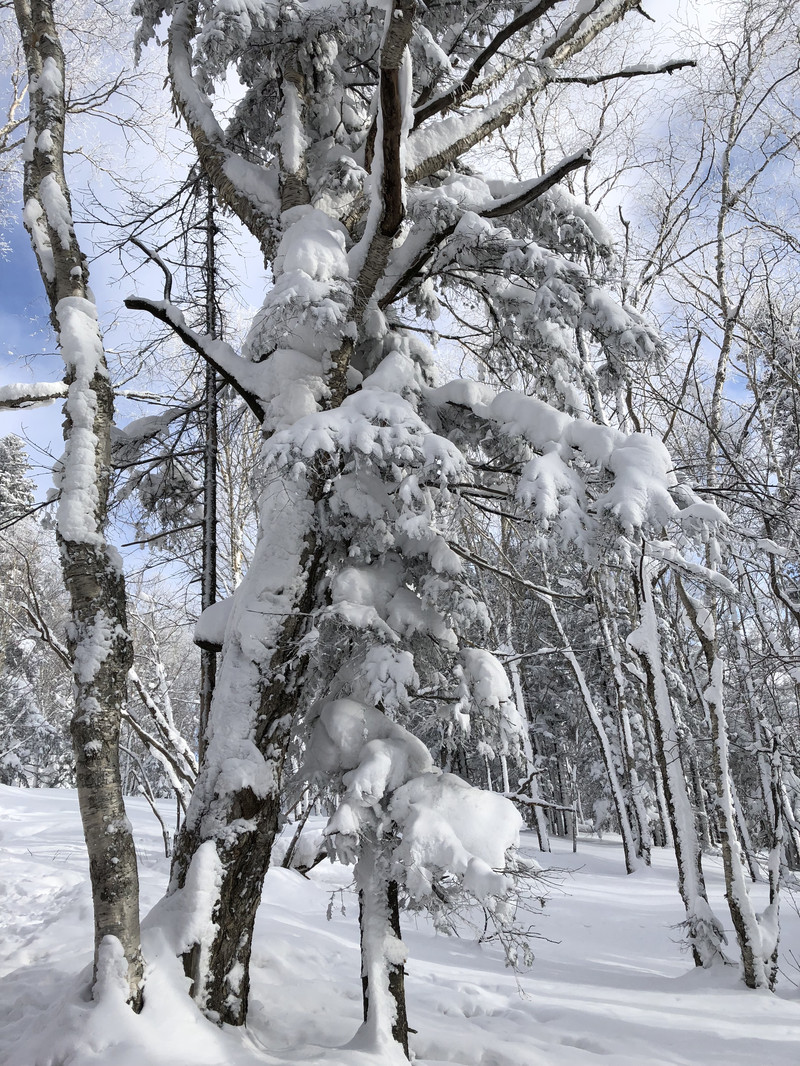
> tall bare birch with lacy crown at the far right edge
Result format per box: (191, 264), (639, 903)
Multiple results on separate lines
(635, 0), (800, 987)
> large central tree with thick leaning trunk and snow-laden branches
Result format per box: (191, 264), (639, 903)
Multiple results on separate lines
(120, 0), (721, 1040)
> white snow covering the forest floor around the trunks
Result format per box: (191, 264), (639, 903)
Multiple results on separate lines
(0, 787), (800, 1066)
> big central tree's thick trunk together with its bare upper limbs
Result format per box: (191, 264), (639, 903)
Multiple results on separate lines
(160, 0), (414, 1024)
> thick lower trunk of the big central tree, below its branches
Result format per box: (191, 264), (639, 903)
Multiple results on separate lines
(169, 480), (324, 1025)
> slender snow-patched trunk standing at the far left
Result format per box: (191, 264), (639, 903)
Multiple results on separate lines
(15, 0), (143, 1010)
